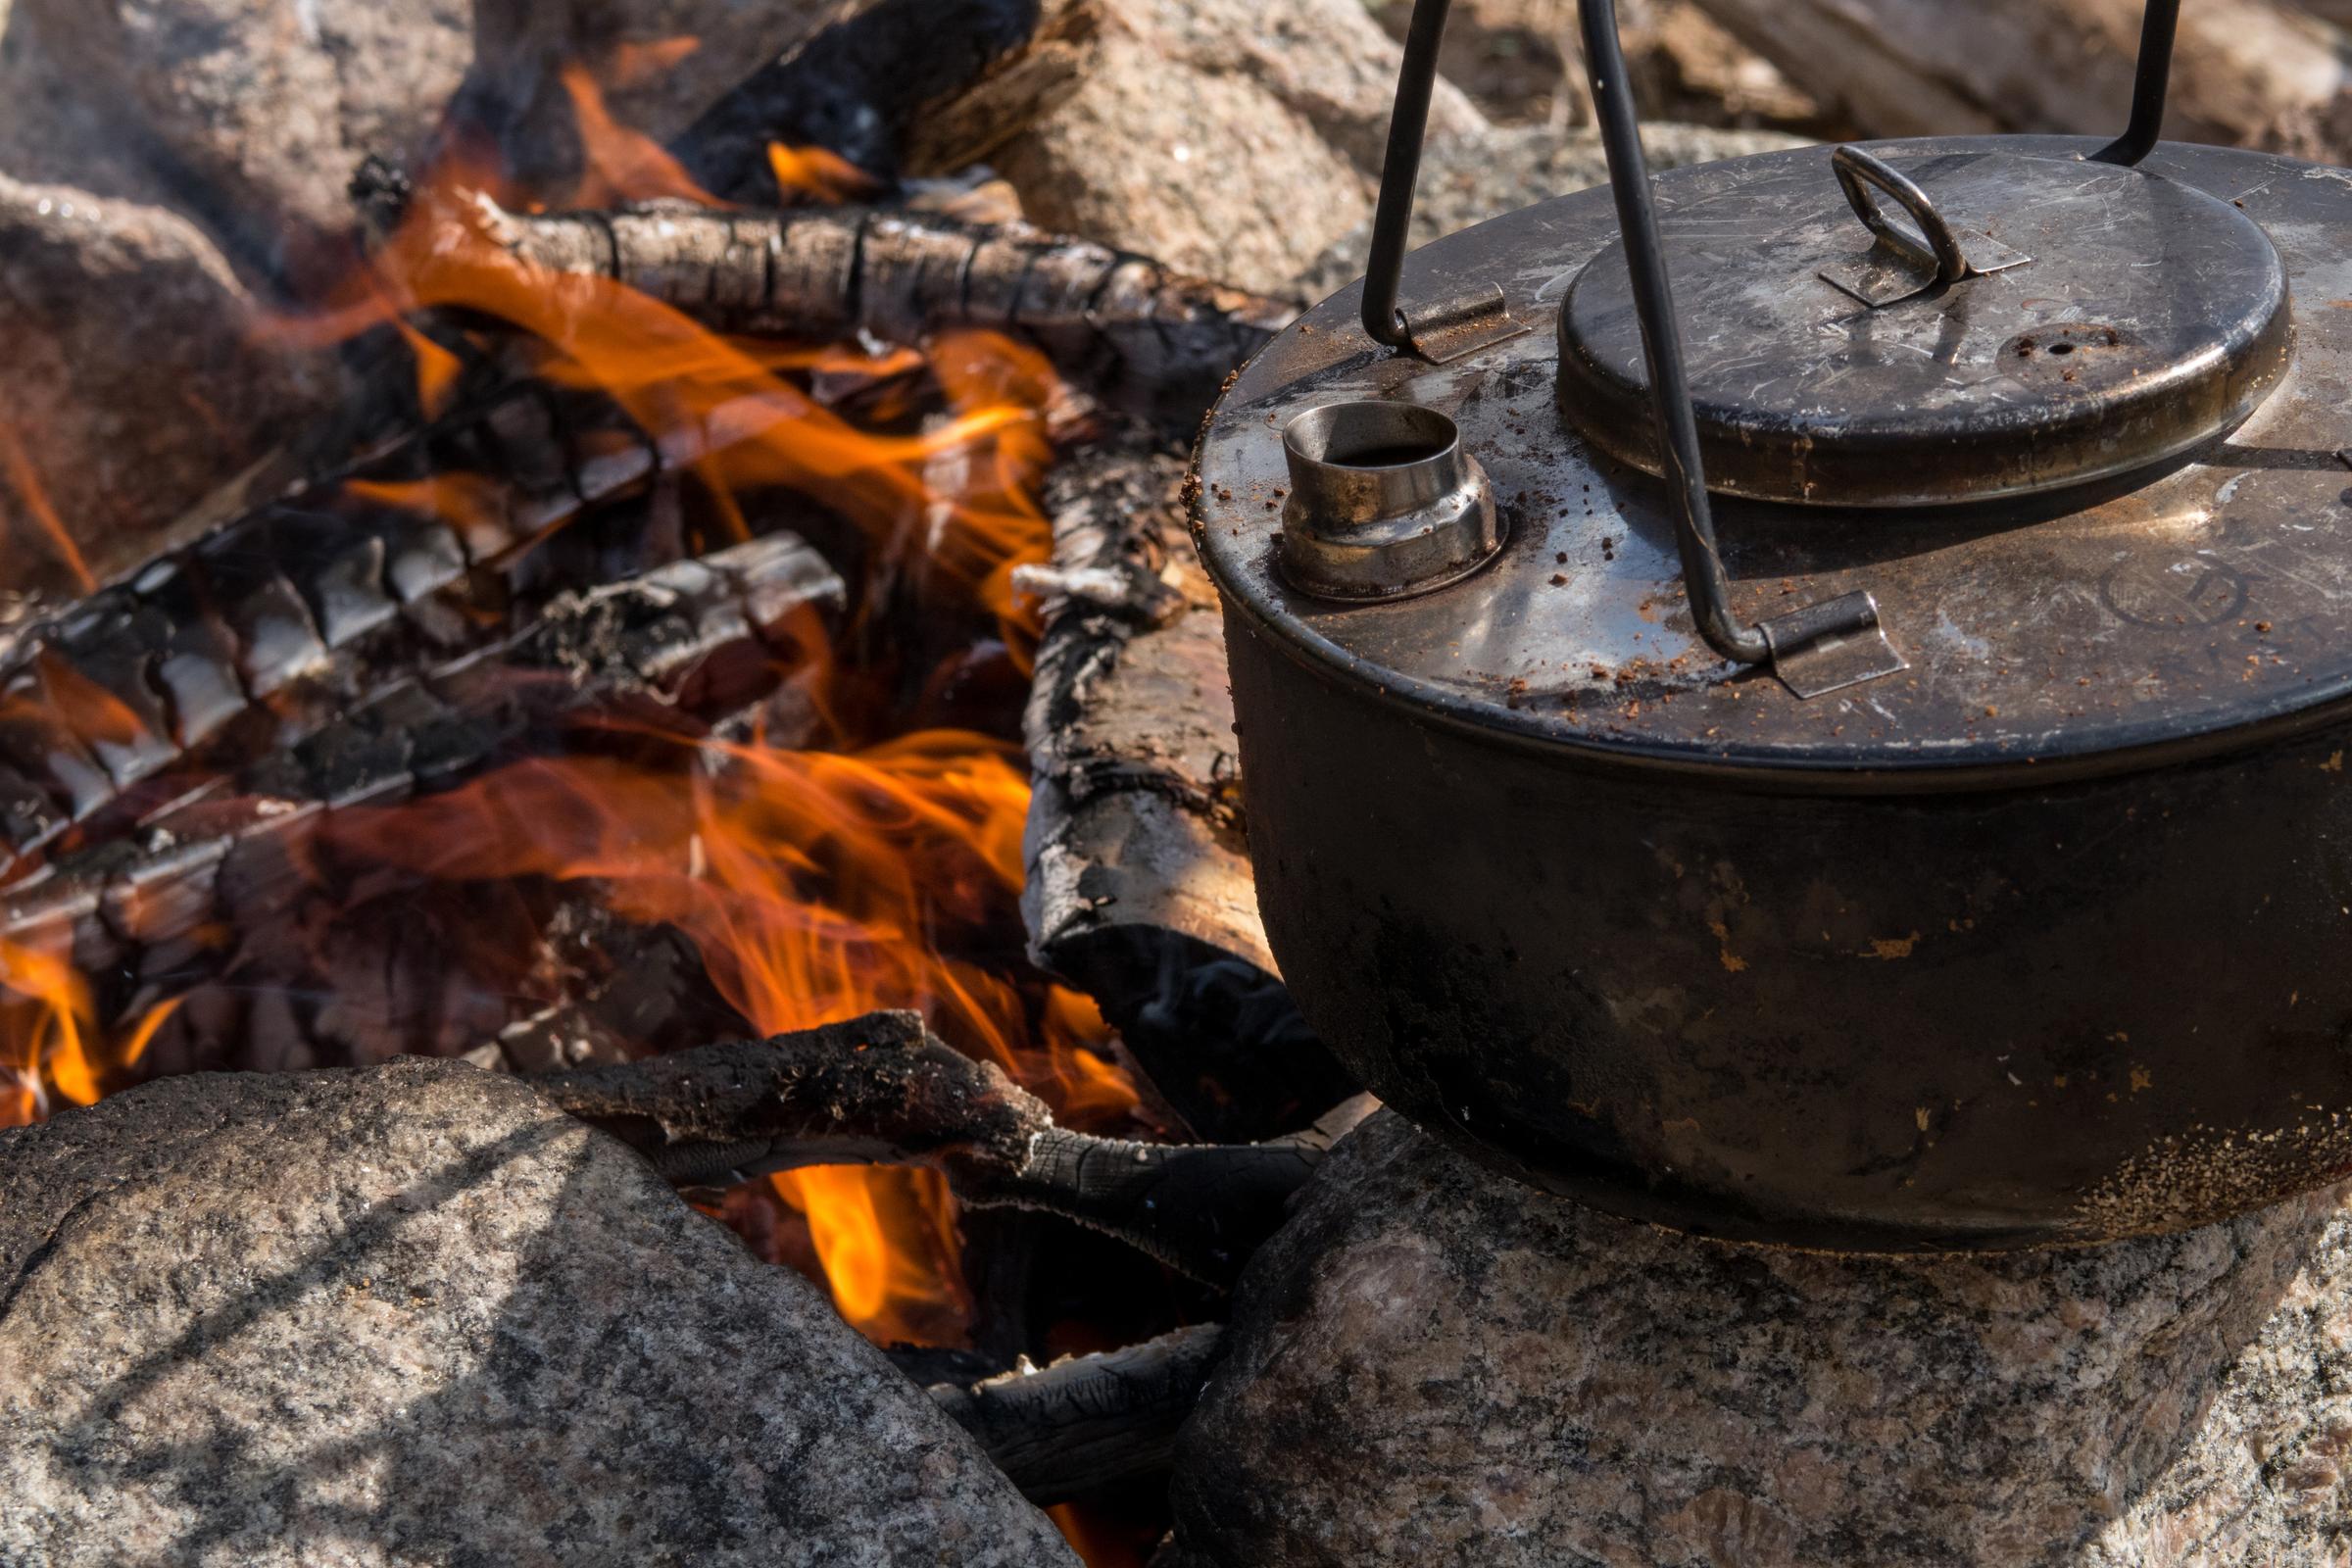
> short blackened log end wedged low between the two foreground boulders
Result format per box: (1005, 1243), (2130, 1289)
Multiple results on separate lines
(929, 1324), (1223, 1504)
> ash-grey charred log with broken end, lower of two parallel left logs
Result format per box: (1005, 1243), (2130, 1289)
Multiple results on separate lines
(0, 534), (845, 1065)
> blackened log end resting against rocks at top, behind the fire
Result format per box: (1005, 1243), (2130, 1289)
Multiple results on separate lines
(670, 0), (1101, 202)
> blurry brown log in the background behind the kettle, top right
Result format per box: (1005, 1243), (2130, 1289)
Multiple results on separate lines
(1698, 0), (2352, 163)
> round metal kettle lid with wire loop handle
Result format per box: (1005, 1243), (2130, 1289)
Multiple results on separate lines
(1559, 143), (2288, 510)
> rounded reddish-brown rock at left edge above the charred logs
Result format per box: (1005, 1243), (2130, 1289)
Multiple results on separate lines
(0, 174), (331, 590)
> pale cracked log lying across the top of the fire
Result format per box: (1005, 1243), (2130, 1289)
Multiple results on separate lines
(432, 197), (1294, 430)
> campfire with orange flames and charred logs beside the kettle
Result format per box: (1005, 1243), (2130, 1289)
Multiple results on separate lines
(0, 30), (1322, 1561)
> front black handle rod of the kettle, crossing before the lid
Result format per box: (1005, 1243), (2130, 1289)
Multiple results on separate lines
(1580, 0), (1771, 665)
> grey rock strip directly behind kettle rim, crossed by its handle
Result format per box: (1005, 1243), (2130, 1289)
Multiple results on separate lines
(1292, 122), (1806, 299)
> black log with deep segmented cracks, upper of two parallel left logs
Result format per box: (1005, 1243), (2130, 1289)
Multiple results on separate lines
(0, 388), (680, 867)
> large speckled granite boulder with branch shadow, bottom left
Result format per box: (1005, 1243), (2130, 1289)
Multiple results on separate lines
(0, 1057), (1075, 1566)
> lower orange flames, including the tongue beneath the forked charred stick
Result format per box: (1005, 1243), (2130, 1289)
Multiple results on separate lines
(324, 731), (1136, 1343)
